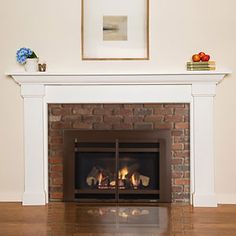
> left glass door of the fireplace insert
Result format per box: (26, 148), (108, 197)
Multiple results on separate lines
(74, 142), (116, 201)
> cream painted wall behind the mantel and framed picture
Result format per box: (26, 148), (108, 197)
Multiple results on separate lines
(0, 0), (236, 203)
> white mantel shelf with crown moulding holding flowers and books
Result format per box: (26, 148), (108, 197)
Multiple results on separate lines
(6, 71), (231, 85)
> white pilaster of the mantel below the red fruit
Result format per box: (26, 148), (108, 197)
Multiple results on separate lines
(192, 83), (217, 207)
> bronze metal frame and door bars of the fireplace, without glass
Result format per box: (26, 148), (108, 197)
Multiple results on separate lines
(63, 129), (171, 203)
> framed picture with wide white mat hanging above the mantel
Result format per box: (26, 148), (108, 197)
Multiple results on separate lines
(81, 0), (149, 60)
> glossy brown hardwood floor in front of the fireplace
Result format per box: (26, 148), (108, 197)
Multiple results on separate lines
(0, 203), (236, 236)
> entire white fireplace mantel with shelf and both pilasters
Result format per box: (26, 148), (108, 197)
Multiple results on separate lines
(8, 71), (229, 206)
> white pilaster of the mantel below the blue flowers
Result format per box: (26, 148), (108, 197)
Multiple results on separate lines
(21, 85), (46, 205)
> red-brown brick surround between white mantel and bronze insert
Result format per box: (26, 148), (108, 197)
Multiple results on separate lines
(48, 103), (190, 202)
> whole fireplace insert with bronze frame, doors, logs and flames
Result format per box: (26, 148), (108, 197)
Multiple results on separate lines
(63, 130), (171, 202)
